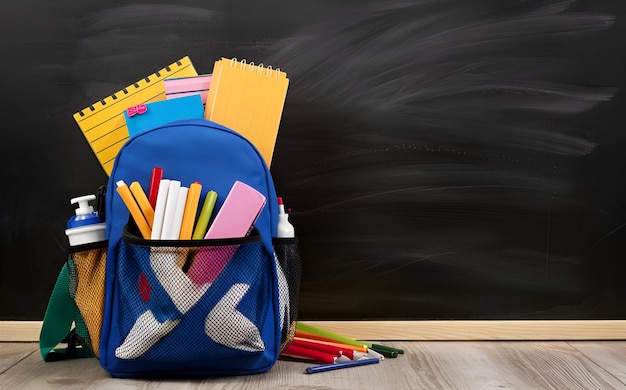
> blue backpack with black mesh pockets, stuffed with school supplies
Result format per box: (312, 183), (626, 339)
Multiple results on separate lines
(87, 119), (300, 377)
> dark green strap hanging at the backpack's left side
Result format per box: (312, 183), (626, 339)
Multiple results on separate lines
(39, 262), (94, 362)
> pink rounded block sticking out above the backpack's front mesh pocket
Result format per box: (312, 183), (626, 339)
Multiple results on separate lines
(204, 181), (265, 239)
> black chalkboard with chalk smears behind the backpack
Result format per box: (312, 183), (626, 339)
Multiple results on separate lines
(0, 0), (626, 320)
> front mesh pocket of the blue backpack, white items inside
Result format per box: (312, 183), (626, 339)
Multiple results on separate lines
(109, 227), (273, 368)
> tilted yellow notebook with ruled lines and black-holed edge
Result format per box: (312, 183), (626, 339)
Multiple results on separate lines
(74, 57), (198, 175)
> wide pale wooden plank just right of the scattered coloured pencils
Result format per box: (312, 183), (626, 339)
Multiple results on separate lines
(407, 341), (626, 389)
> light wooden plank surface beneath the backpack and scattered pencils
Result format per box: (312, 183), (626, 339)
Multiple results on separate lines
(0, 341), (626, 390)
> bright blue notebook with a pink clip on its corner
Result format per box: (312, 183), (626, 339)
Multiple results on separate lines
(124, 95), (204, 137)
